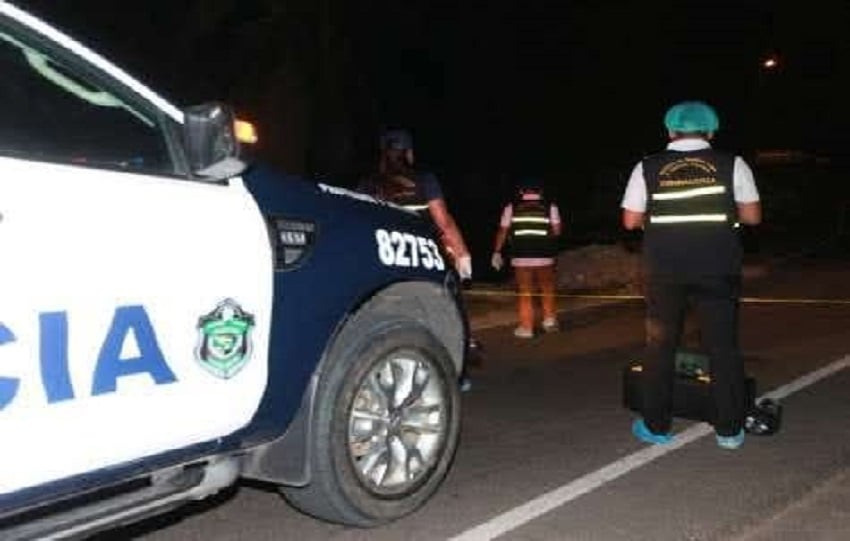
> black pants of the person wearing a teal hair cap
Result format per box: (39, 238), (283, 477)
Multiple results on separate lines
(642, 276), (746, 436)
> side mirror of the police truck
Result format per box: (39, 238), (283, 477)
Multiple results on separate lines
(183, 102), (246, 180)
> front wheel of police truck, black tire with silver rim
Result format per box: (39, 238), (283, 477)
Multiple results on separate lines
(281, 310), (460, 527)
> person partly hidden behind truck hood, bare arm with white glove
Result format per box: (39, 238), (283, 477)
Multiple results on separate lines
(358, 129), (472, 280)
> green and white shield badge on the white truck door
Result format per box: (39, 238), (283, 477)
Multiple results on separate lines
(195, 299), (254, 379)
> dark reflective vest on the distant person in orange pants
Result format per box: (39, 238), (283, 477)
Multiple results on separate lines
(508, 198), (558, 257)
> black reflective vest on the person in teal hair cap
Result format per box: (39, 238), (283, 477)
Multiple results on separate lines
(643, 148), (741, 276)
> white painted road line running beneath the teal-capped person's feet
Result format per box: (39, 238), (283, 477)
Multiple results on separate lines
(449, 355), (850, 541)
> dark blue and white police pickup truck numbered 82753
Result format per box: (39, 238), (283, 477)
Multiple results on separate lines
(0, 0), (468, 540)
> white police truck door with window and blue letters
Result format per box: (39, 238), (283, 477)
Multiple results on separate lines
(0, 18), (273, 495)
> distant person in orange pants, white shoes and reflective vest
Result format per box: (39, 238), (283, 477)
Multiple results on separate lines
(491, 178), (561, 338)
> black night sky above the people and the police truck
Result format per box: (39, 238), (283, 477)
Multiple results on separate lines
(14, 0), (850, 260)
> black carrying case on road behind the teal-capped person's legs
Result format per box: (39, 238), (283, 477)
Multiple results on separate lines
(623, 351), (756, 423)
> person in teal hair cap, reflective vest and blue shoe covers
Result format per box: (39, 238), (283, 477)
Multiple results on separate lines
(621, 101), (761, 449)
